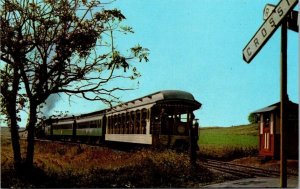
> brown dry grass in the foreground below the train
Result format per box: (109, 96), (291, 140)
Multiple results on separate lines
(1, 139), (214, 188)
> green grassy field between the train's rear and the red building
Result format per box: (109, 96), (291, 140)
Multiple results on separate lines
(198, 124), (258, 159)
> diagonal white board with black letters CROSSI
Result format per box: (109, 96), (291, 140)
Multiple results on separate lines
(243, 0), (298, 63)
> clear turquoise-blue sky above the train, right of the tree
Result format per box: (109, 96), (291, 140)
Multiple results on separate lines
(4, 0), (299, 126)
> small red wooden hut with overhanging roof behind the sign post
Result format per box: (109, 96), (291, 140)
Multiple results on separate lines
(253, 101), (299, 159)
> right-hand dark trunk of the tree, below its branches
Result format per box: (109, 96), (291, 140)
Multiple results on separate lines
(26, 103), (37, 169)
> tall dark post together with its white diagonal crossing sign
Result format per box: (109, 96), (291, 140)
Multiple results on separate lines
(243, 0), (298, 188)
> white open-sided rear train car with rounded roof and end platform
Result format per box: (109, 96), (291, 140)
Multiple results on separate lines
(105, 90), (201, 147)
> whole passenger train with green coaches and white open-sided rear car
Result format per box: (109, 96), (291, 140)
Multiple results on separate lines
(38, 90), (201, 148)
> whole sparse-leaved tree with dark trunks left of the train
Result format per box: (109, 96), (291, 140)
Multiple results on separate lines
(0, 0), (149, 171)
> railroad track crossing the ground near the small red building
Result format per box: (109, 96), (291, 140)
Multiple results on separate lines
(200, 158), (298, 178)
